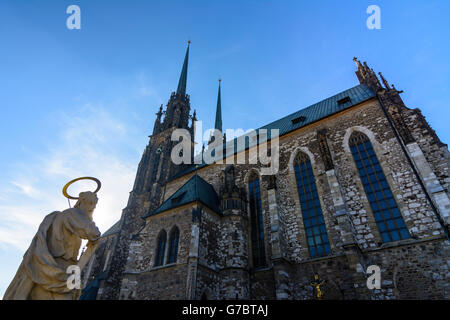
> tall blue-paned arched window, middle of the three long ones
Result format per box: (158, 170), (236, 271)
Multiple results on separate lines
(294, 153), (331, 257)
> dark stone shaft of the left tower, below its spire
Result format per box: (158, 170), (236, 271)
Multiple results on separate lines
(103, 99), (190, 299)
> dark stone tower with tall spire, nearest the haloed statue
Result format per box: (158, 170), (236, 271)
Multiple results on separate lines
(101, 41), (195, 299)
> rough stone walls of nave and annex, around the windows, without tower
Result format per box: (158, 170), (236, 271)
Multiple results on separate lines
(103, 94), (450, 299)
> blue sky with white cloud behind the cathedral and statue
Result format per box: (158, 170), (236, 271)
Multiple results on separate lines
(0, 0), (450, 296)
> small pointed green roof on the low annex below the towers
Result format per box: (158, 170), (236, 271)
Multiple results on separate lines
(142, 175), (221, 218)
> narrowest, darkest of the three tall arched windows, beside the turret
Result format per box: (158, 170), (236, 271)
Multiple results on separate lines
(249, 175), (266, 268)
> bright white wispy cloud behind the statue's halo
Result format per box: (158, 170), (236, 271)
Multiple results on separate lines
(0, 104), (137, 251)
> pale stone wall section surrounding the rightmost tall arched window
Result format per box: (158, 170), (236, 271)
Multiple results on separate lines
(327, 101), (442, 249)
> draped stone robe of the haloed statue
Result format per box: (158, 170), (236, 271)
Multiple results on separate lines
(3, 208), (100, 300)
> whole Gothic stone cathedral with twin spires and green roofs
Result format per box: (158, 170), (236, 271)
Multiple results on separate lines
(81, 45), (450, 300)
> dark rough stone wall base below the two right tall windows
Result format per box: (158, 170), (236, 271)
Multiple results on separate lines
(282, 239), (450, 300)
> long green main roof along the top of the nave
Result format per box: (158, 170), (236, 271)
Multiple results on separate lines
(167, 84), (376, 180)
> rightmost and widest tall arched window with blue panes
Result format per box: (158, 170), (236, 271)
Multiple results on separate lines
(349, 131), (410, 242)
